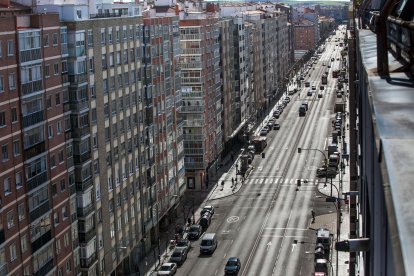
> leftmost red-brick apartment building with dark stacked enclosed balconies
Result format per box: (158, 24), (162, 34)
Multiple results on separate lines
(0, 9), (77, 275)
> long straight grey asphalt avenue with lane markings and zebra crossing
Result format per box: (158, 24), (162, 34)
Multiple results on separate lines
(173, 29), (348, 276)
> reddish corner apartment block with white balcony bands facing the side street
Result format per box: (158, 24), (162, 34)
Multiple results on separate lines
(180, 10), (223, 189)
